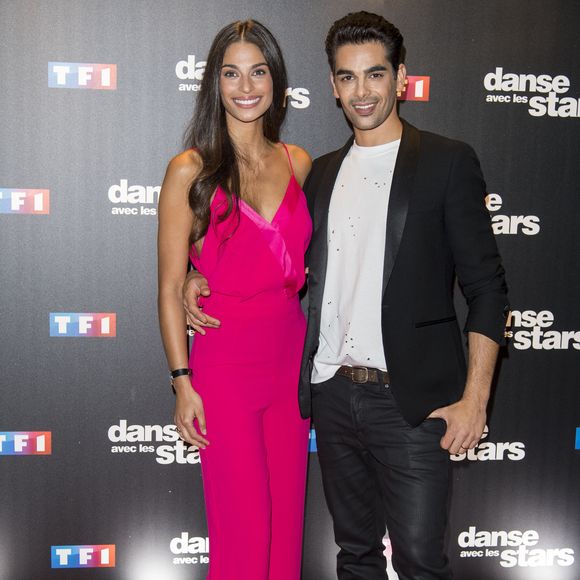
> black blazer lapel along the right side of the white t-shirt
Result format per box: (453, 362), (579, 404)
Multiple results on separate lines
(383, 121), (420, 296)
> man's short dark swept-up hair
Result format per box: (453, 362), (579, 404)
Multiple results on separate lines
(325, 10), (404, 77)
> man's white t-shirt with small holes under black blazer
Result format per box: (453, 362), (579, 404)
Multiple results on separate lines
(312, 140), (400, 383)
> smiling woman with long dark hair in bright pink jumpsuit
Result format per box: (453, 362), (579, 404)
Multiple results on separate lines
(158, 20), (312, 580)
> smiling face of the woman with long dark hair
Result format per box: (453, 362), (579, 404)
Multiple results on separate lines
(220, 42), (274, 123)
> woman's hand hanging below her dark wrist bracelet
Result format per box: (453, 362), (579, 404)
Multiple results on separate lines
(173, 376), (209, 449)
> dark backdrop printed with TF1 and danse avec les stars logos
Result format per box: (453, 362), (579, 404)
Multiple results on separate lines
(0, 0), (580, 580)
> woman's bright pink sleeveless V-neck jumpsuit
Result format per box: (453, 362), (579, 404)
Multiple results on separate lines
(190, 146), (312, 580)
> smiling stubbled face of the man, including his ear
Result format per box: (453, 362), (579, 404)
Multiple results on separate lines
(330, 42), (406, 131)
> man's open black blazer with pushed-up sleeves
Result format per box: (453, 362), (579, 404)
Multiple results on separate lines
(299, 121), (509, 426)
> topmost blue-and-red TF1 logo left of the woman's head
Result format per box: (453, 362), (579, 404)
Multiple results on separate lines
(48, 62), (117, 91)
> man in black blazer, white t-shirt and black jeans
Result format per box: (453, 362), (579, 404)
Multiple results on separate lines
(189, 12), (508, 580)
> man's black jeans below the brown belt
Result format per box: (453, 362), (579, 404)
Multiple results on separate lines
(312, 376), (451, 580)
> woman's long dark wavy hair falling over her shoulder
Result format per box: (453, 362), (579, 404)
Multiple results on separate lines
(185, 20), (288, 242)
